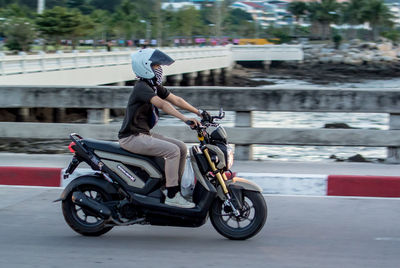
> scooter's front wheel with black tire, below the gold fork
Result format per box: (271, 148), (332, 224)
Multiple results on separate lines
(210, 190), (267, 240)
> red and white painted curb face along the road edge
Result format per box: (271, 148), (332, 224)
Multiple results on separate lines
(0, 167), (400, 197)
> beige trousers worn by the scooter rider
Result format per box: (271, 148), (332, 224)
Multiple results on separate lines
(119, 133), (187, 187)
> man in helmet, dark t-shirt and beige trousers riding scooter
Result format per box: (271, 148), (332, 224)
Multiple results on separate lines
(118, 48), (210, 208)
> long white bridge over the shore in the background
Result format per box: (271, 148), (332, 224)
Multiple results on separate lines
(0, 45), (303, 86)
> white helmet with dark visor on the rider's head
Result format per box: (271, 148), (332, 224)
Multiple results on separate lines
(131, 48), (175, 79)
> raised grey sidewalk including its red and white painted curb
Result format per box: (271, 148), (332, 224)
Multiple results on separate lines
(0, 153), (400, 197)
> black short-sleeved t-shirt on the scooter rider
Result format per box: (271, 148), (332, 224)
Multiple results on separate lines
(118, 81), (170, 139)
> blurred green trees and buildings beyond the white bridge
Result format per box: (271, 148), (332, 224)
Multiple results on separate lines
(0, 0), (400, 53)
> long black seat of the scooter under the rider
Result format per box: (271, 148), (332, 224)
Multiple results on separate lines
(82, 139), (165, 172)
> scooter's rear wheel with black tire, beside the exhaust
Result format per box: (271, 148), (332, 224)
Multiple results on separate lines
(62, 184), (113, 236)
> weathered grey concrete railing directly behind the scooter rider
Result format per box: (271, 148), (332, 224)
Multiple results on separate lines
(0, 86), (400, 163)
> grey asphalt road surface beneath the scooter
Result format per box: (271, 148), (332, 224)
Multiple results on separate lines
(0, 187), (400, 268)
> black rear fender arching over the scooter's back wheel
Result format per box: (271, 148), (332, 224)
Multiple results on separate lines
(54, 175), (118, 202)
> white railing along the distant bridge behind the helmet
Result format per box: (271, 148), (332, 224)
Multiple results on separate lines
(0, 45), (303, 75)
